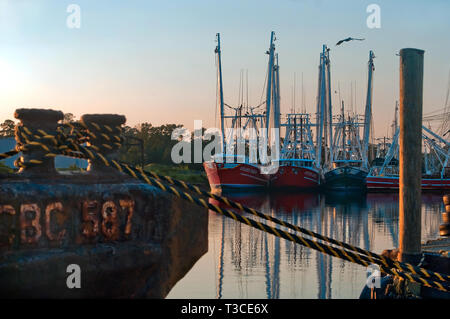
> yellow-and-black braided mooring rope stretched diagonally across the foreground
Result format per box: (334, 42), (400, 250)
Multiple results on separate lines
(7, 122), (449, 291)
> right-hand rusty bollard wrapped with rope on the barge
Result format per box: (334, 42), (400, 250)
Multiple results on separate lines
(80, 114), (126, 174)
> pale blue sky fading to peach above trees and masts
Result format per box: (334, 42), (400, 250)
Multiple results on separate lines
(0, 0), (450, 136)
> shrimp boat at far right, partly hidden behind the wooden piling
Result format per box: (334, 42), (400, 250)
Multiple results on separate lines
(366, 126), (450, 191)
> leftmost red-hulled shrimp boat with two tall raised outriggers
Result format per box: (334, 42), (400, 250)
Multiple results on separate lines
(203, 32), (279, 192)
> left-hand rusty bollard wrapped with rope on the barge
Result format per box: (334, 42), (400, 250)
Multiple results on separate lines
(14, 109), (64, 176)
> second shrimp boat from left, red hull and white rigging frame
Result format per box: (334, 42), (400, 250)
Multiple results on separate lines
(270, 113), (320, 189)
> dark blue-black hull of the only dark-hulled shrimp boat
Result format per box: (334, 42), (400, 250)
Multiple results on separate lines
(324, 166), (367, 191)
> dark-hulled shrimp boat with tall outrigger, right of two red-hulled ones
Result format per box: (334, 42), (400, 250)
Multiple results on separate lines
(324, 51), (375, 191)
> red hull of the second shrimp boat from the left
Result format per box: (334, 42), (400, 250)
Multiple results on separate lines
(270, 165), (320, 189)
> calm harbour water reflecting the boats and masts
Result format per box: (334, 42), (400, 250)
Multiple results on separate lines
(167, 193), (444, 298)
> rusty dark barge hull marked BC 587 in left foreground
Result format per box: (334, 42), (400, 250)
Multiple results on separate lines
(0, 173), (208, 298)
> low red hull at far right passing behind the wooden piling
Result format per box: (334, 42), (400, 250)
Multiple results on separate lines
(366, 176), (450, 191)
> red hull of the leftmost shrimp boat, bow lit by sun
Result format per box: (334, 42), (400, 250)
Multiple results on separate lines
(203, 162), (269, 191)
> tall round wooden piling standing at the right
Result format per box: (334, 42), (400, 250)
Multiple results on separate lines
(399, 49), (424, 264)
